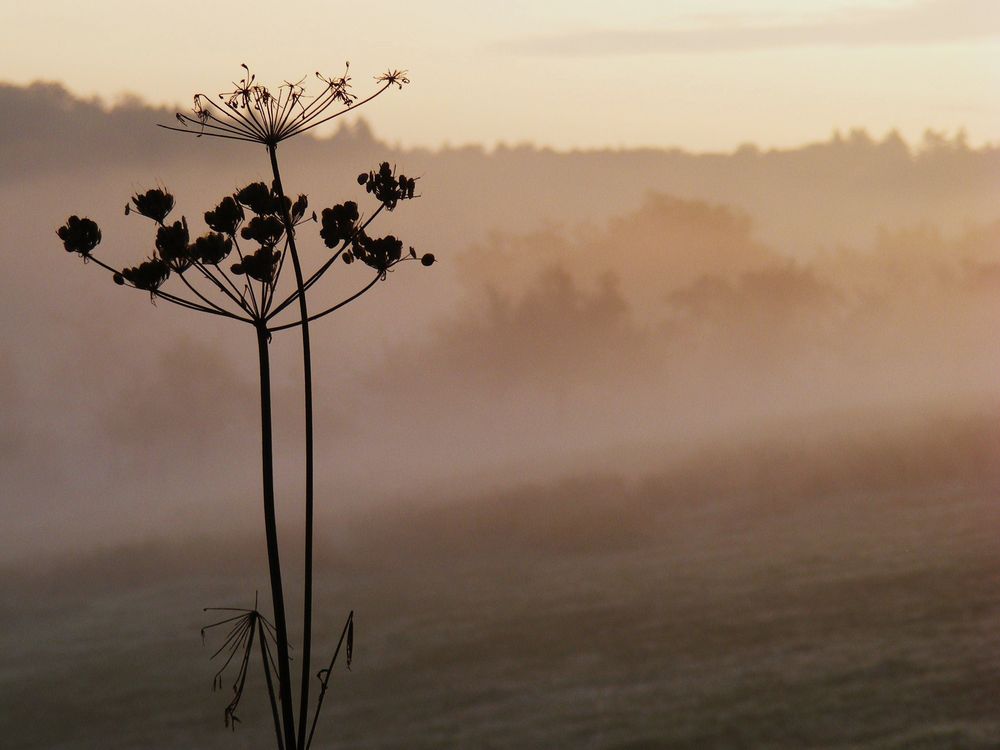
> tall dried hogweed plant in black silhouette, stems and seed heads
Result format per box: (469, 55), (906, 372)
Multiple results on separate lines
(57, 65), (434, 750)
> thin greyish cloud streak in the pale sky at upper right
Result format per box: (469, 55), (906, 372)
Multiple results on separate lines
(501, 0), (1000, 56)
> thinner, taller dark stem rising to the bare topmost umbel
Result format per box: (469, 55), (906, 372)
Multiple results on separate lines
(267, 143), (314, 748)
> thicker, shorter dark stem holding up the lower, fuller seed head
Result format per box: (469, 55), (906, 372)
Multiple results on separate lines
(257, 321), (295, 748)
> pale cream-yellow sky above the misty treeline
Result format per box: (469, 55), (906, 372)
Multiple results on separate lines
(0, 0), (1000, 151)
